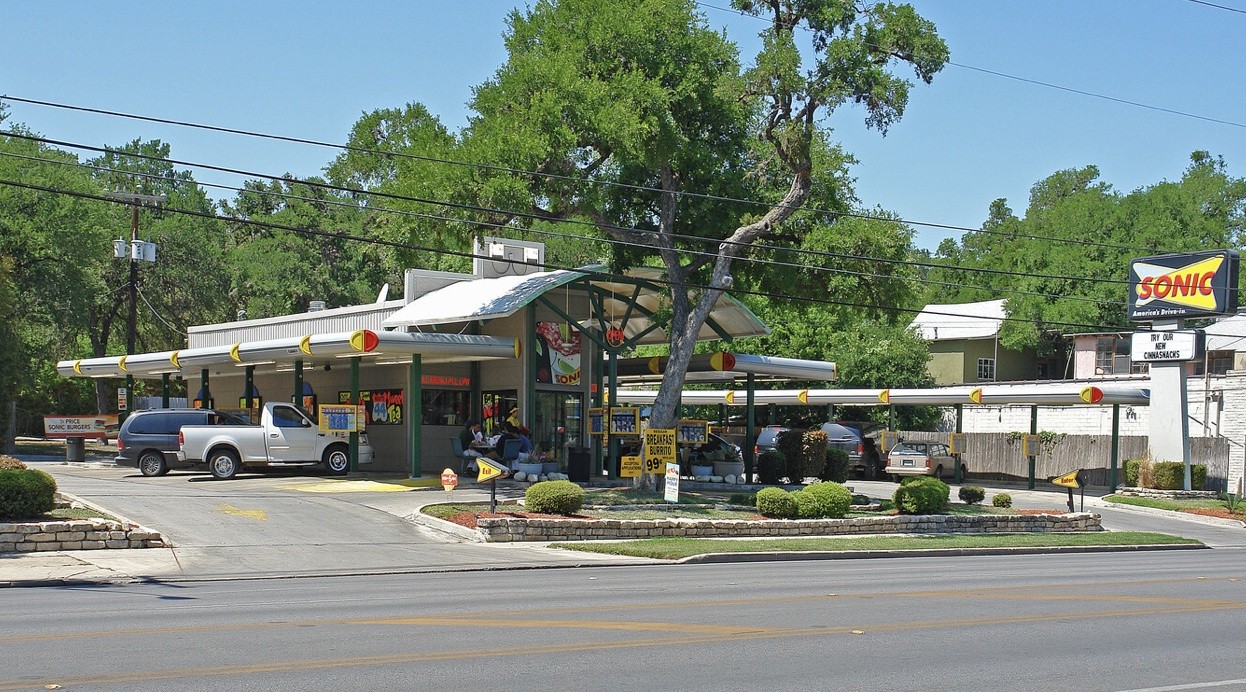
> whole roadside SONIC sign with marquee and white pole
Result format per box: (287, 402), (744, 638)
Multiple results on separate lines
(1129, 249), (1239, 490)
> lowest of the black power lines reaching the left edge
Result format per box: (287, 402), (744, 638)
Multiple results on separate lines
(0, 174), (1141, 330)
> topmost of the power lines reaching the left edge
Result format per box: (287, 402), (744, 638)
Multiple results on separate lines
(0, 95), (1154, 252)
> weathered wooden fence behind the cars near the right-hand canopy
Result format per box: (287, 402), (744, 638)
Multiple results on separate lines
(900, 431), (1229, 491)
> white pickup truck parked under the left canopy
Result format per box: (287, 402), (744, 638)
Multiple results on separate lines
(177, 401), (373, 479)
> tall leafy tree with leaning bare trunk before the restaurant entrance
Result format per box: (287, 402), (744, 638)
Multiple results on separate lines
(465, 0), (947, 491)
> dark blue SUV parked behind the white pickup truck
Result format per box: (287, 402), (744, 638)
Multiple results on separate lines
(113, 409), (247, 476)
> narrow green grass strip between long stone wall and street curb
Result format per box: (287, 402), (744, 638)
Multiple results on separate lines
(552, 531), (1202, 560)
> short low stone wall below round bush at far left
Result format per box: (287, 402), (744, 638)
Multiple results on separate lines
(0, 519), (166, 552)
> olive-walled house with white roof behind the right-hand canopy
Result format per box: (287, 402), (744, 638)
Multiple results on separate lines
(910, 299), (1049, 385)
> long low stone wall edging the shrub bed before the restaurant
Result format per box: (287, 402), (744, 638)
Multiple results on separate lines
(476, 512), (1103, 542)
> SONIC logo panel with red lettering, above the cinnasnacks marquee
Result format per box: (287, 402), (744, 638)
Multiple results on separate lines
(1129, 249), (1239, 322)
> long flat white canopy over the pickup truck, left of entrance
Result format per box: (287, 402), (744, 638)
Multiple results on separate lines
(56, 329), (520, 378)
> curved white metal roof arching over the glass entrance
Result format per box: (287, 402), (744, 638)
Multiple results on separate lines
(383, 264), (770, 345)
